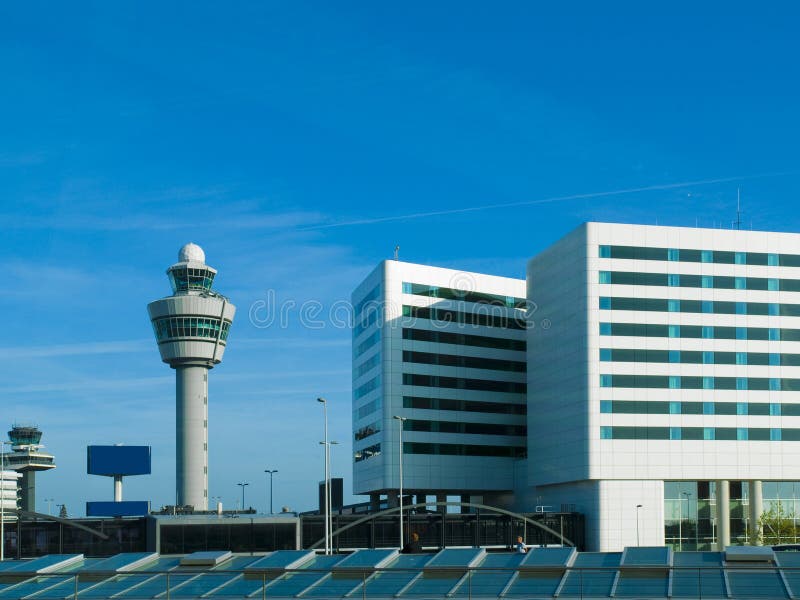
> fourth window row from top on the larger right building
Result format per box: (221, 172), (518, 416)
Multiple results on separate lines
(600, 323), (800, 342)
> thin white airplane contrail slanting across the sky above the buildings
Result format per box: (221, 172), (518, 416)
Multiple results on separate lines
(298, 171), (797, 231)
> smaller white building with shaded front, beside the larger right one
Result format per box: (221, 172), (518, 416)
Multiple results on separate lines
(352, 261), (526, 503)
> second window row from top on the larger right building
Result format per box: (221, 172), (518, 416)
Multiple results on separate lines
(599, 271), (800, 292)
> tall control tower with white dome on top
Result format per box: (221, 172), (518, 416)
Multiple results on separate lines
(147, 244), (236, 510)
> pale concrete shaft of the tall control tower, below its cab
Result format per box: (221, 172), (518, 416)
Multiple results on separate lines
(175, 365), (208, 510)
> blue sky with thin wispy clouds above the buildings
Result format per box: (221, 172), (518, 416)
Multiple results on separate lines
(0, 2), (800, 514)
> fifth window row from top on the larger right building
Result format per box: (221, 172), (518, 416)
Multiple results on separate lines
(600, 348), (800, 367)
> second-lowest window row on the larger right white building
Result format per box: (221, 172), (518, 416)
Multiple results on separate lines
(600, 400), (800, 417)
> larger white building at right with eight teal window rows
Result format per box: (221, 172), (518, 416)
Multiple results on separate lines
(527, 223), (800, 550)
